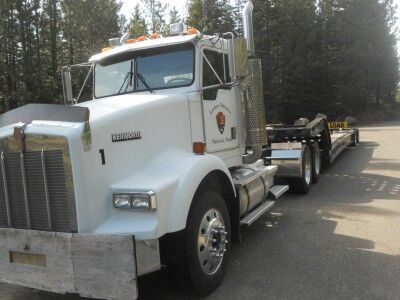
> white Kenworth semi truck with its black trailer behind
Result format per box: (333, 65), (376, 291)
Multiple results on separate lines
(0, 1), (358, 299)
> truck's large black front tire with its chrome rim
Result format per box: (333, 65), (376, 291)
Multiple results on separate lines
(167, 190), (231, 296)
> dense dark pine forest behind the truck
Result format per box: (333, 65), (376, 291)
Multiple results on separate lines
(0, 0), (399, 122)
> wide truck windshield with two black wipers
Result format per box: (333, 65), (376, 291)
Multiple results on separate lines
(94, 45), (194, 98)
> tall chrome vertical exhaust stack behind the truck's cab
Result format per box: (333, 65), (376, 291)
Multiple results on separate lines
(242, 0), (267, 164)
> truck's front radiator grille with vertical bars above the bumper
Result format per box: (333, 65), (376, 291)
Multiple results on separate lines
(0, 150), (73, 232)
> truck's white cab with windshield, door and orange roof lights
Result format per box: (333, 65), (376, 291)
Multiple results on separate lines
(88, 29), (247, 168)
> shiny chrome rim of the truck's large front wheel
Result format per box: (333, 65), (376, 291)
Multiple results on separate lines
(197, 208), (228, 275)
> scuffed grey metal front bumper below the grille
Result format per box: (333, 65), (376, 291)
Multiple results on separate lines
(0, 229), (160, 299)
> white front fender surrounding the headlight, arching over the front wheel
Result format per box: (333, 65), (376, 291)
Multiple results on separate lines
(95, 149), (235, 239)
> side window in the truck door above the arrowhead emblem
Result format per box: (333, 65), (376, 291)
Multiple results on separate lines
(203, 50), (231, 100)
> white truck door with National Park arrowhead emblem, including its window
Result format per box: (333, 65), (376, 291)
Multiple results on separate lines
(202, 48), (239, 153)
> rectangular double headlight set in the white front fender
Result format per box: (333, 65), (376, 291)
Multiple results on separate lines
(113, 191), (157, 210)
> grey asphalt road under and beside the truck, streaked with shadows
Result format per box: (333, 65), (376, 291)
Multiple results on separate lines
(0, 122), (400, 300)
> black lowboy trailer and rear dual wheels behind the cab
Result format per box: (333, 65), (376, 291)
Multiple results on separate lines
(263, 117), (359, 194)
